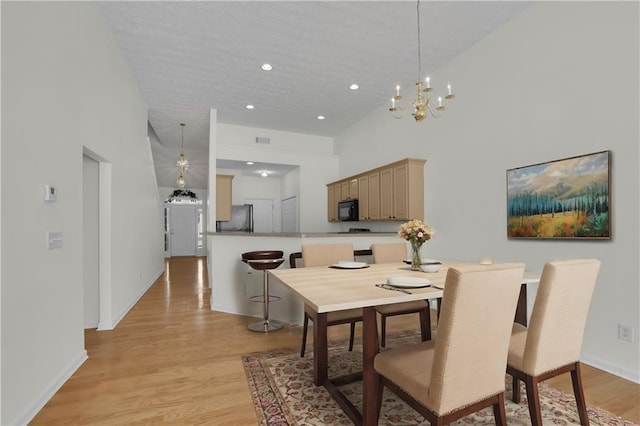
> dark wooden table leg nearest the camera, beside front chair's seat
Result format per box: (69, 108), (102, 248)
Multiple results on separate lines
(362, 307), (378, 425)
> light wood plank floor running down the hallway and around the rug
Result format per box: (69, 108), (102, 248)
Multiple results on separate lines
(30, 258), (640, 426)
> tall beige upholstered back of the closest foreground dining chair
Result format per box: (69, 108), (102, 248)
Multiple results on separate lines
(427, 263), (524, 415)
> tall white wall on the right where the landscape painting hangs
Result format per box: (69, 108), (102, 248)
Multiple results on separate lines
(335, 2), (640, 382)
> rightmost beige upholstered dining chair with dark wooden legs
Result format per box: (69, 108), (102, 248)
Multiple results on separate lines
(507, 259), (600, 426)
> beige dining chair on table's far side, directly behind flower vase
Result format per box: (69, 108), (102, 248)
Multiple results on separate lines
(371, 242), (431, 348)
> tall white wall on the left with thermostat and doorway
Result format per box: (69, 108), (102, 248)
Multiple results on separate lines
(0, 2), (164, 425)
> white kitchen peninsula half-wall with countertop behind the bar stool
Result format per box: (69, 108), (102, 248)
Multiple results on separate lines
(207, 232), (399, 324)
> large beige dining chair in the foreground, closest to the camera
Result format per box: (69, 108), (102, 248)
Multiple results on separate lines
(374, 263), (524, 425)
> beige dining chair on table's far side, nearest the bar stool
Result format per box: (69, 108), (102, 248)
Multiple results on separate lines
(300, 244), (362, 357)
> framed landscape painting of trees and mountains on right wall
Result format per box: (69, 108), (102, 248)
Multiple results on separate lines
(507, 151), (611, 240)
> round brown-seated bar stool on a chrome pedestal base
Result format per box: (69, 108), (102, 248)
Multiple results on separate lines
(242, 250), (284, 333)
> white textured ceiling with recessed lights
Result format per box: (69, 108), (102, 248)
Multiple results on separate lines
(101, 1), (528, 189)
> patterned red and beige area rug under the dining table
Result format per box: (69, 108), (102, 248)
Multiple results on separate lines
(242, 334), (637, 426)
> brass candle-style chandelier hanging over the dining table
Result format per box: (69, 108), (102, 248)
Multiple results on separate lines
(389, 0), (455, 121)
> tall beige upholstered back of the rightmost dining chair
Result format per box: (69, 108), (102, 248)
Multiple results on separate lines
(518, 259), (600, 376)
